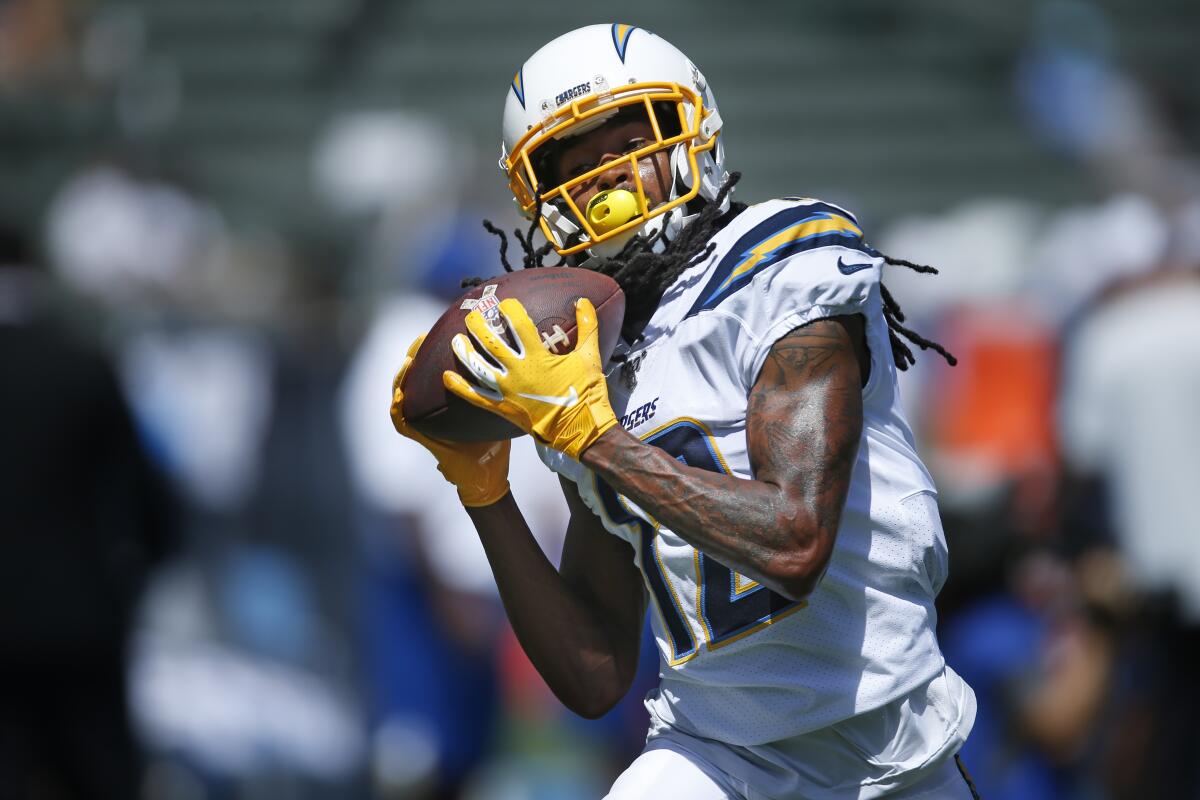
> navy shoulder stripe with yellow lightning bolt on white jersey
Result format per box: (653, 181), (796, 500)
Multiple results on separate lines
(684, 203), (877, 319)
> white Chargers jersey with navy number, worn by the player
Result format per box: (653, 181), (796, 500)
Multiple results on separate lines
(539, 199), (973, 747)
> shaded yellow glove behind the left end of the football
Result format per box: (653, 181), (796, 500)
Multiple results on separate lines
(391, 333), (510, 506)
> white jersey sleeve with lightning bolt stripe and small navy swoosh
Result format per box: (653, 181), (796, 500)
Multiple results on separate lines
(690, 200), (883, 391)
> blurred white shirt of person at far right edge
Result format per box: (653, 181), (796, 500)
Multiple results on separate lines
(1058, 269), (1200, 624)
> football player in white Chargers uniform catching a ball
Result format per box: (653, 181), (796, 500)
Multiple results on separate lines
(391, 24), (976, 800)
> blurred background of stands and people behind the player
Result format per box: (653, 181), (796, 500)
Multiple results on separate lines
(0, 0), (1200, 800)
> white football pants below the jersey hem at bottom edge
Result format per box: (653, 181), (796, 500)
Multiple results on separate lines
(605, 742), (973, 800)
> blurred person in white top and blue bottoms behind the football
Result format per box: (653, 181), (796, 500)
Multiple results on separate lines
(340, 215), (585, 796)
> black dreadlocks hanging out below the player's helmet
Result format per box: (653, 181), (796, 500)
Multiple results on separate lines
(472, 173), (958, 369)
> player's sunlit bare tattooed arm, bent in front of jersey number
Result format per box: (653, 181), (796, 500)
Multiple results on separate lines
(581, 315), (870, 600)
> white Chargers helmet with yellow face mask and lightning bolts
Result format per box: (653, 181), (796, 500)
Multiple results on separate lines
(500, 23), (728, 255)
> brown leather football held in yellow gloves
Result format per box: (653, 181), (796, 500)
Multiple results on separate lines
(401, 266), (625, 441)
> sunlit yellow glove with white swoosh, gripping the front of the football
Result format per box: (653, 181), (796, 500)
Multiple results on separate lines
(442, 297), (617, 458)
